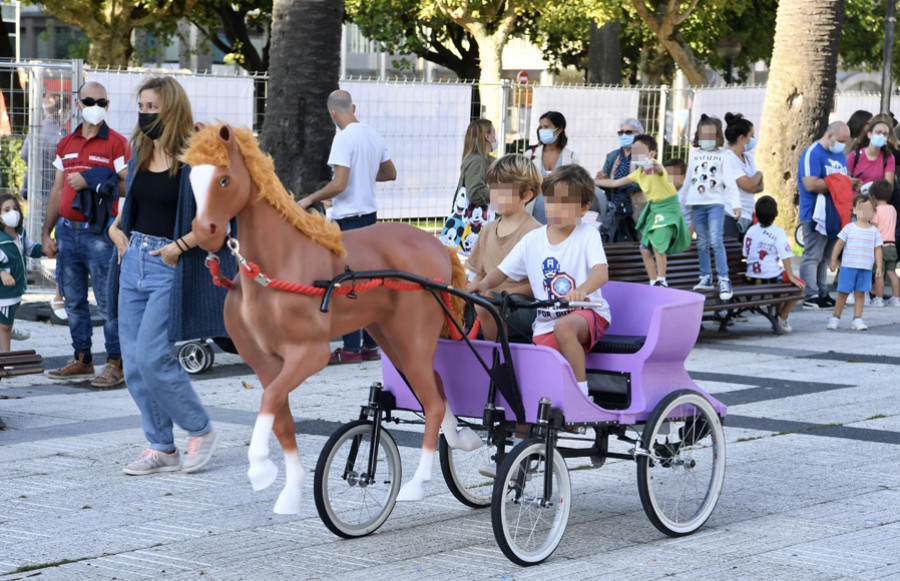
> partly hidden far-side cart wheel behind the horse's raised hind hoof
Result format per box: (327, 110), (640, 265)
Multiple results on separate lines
(438, 428), (497, 508)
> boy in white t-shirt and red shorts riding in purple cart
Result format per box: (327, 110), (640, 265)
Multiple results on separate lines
(469, 164), (610, 395)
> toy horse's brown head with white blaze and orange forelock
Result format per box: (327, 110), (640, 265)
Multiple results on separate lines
(183, 125), (253, 251)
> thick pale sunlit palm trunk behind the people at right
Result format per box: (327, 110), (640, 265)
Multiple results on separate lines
(756, 0), (844, 232)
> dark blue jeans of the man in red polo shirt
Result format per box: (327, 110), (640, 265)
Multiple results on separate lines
(56, 219), (122, 363)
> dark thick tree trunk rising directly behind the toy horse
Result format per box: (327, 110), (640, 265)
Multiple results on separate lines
(262, 0), (344, 197)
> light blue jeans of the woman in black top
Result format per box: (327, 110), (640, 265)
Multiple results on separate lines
(119, 232), (211, 452)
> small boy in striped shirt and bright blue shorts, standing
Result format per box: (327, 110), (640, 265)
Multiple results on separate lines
(825, 194), (883, 331)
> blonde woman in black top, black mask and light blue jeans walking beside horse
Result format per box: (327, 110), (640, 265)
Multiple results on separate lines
(110, 77), (222, 476)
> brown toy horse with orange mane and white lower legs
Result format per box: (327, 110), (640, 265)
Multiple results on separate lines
(183, 125), (482, 514)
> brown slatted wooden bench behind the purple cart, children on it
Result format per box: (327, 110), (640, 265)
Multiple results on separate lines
(604, 238), (803, 335)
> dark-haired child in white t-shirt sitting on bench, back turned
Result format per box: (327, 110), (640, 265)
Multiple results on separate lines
(743, 196), (806, 333)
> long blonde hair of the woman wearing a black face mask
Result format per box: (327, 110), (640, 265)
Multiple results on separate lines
(131, 77), (194, 176)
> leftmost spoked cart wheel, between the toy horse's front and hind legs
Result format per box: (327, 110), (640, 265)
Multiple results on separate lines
(314, 420), (401, 538)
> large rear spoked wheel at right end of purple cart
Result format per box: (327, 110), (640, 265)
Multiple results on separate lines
(637, 390), (725, 537)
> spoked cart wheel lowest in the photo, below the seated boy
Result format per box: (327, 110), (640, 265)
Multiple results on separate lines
(491, 438), (572, 567)
